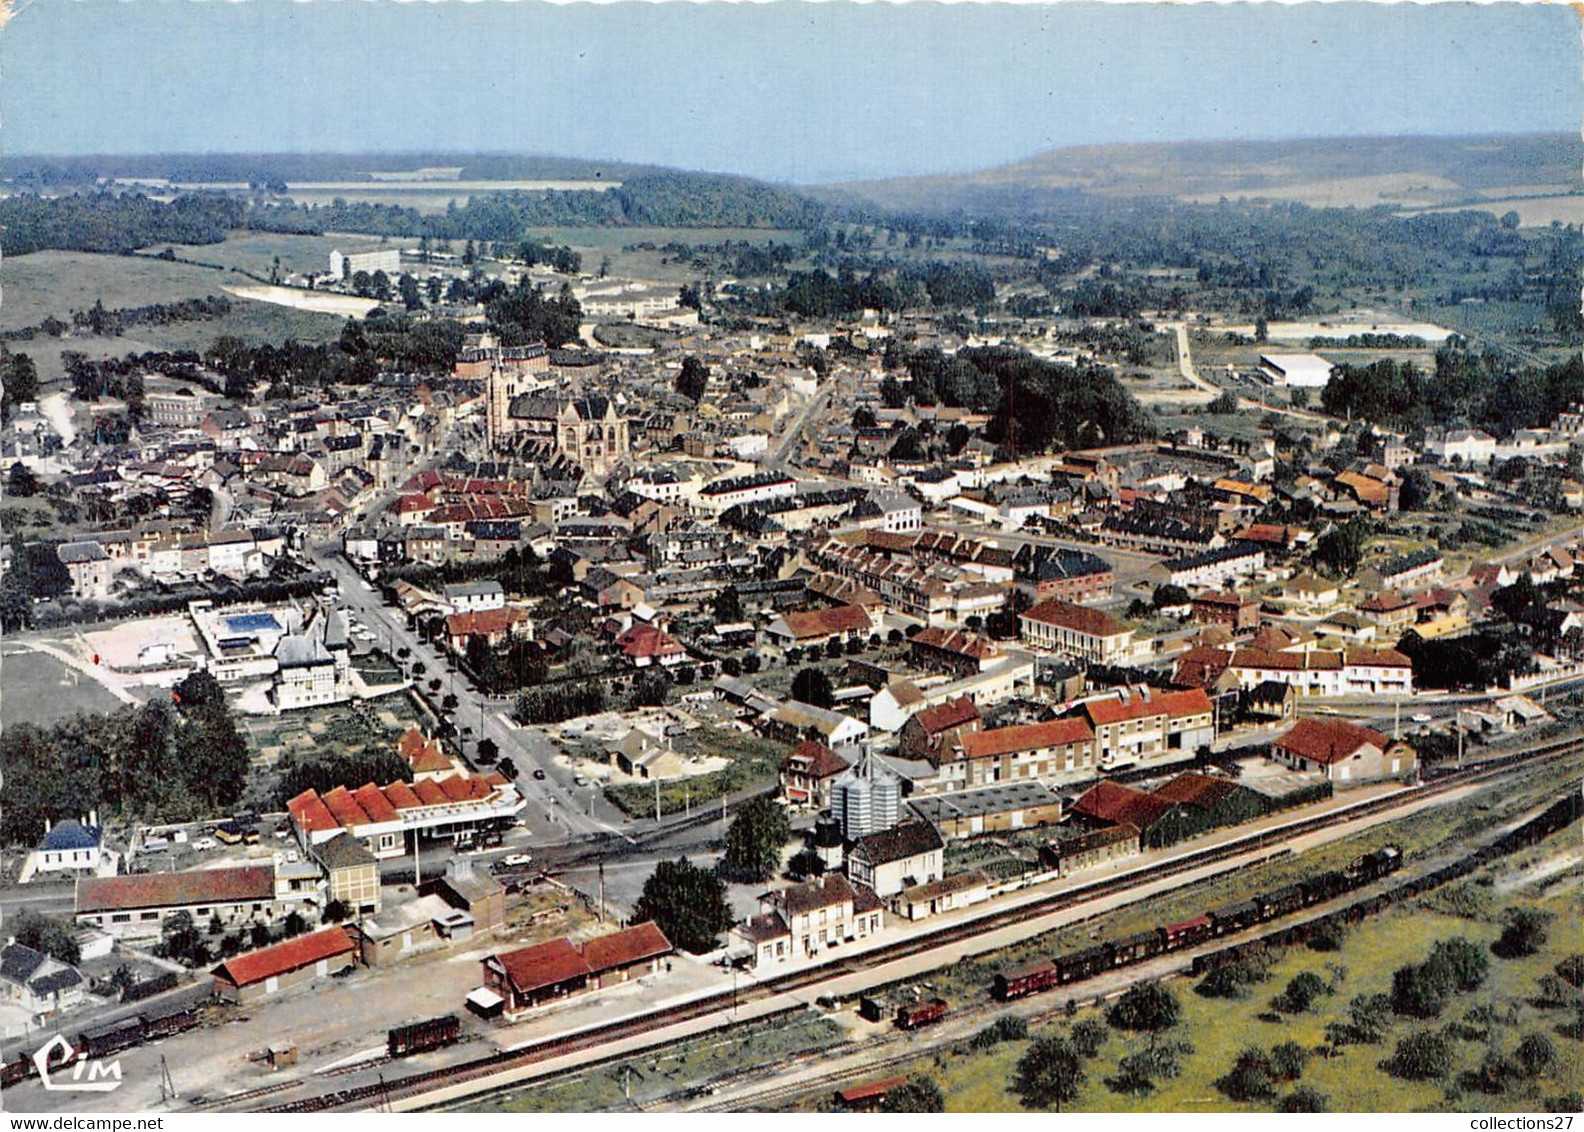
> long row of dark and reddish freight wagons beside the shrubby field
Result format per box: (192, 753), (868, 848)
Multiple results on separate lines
(990, 845), (1402, 1002)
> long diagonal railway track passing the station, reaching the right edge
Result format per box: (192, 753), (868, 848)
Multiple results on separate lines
(253, 736), (1584, 1113)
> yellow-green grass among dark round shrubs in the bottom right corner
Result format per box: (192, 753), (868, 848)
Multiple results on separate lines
(880, 828), (1584, 1111)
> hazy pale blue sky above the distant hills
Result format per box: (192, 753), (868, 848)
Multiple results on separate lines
(0, 0), (1584, 184)
